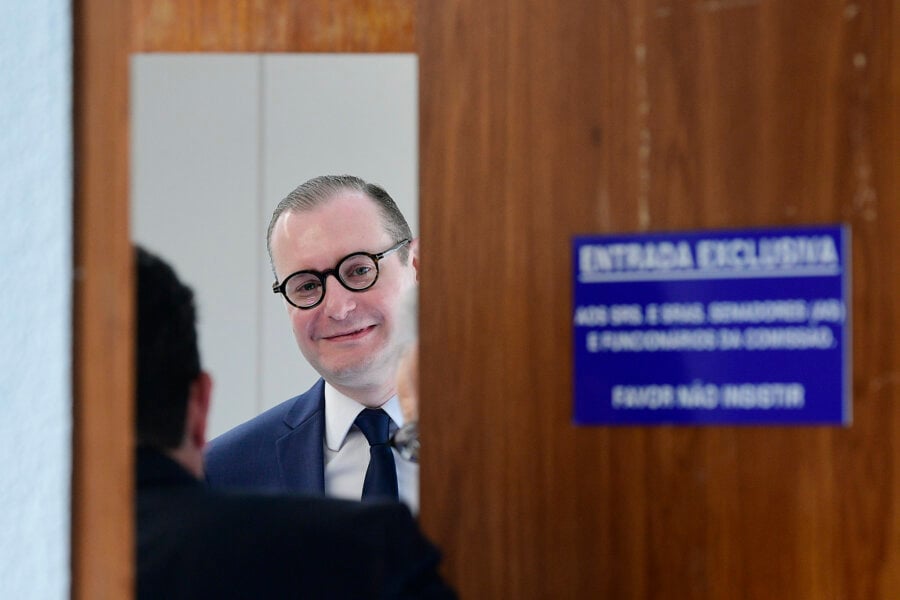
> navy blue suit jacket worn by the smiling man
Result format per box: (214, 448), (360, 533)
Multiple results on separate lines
(205, 379), (325, 494)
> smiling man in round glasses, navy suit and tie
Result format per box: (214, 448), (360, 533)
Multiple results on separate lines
(206, 176), (419, 512)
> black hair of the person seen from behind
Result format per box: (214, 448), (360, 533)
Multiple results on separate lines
(135, 247), (200, 449)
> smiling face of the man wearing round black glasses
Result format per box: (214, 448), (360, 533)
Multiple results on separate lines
(271, 191), (417, 403)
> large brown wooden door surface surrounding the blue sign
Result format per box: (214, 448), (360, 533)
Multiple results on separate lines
(417, 0), (900, 599)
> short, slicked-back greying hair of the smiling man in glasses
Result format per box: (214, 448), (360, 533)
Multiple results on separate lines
(266, 175), (412, 275)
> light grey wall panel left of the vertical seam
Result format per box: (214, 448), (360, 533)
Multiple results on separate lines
(131, 54), (263, 436)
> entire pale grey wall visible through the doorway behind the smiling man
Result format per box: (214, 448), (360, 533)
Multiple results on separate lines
(131, 54), (418, 436)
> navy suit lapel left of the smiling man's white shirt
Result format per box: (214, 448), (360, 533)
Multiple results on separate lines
(275, 379), (325, 494)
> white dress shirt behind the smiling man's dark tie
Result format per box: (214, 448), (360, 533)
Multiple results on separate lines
(325, 382), (419, 514)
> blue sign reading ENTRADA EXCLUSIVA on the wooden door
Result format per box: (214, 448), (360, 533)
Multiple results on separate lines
(572, 226), (851, 425)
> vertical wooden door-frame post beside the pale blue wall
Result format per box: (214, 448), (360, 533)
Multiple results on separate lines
(72, 0), (135, 600)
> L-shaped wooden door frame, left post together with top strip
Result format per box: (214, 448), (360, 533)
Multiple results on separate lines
(72, 0), (415, 600)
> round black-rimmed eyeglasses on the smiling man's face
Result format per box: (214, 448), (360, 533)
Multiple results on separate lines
(272, 239), (410, 310)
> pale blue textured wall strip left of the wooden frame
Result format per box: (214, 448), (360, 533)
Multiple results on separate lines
(0, 0), (72, 600)
